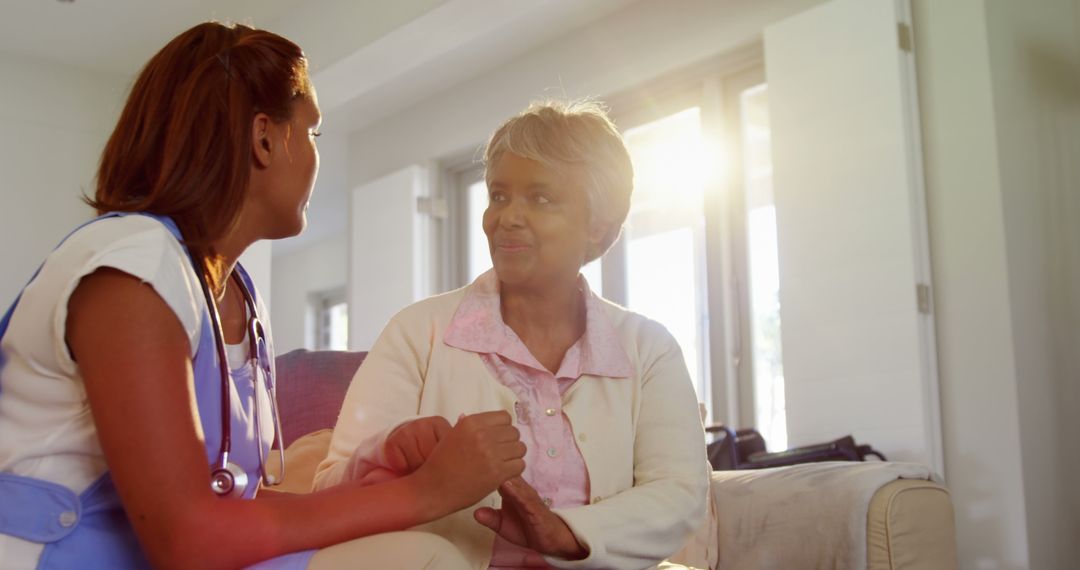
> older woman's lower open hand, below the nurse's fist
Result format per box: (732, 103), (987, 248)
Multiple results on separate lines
(473, 477), (589, 564)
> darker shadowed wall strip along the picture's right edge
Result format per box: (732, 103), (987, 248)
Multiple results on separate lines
(986, 0), (1080, 568)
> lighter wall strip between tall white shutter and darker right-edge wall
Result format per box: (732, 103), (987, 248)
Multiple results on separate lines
(913, 0), (1028, 568)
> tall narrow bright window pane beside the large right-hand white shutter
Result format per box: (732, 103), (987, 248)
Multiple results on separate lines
(741, 85), (787, 450)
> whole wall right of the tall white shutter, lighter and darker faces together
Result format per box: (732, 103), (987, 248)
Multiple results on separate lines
(915, 0), (1080, 568)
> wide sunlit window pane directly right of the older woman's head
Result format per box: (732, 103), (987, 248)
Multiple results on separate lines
(623, 107), (712, 407)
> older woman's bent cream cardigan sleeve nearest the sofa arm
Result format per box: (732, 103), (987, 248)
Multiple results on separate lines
(545, 322), (708, 569)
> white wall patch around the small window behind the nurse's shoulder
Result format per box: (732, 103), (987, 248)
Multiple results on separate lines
(270, 232), (348, 354)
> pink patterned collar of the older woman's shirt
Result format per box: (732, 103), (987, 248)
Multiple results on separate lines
(443, 270), (633, 378)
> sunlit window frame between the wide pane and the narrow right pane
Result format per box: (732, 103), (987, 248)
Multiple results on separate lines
(604, 43), (766, 428)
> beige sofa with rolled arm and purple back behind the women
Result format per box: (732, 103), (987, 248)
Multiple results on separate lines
(270, 350), (957, 570)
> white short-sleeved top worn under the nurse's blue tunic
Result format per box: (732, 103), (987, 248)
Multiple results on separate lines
(0, 216), (247, 567)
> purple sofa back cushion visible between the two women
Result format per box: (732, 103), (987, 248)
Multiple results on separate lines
(274, 349), (367, 447)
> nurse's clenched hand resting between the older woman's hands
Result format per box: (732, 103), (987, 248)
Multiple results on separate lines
(413, 411), (525, 512)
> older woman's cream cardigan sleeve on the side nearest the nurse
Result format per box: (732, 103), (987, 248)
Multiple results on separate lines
(313, 308), (431, 490)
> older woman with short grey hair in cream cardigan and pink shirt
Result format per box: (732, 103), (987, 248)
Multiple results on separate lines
(315, 103), (707, 569)
